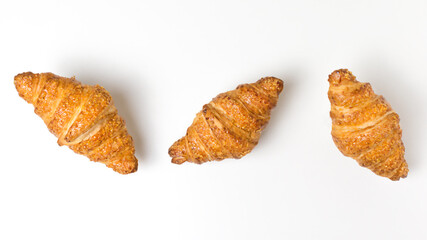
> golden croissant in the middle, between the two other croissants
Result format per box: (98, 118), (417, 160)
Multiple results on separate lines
(169, 77), (283, 164)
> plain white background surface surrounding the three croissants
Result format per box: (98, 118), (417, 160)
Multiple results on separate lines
(0, 0), (427, 239)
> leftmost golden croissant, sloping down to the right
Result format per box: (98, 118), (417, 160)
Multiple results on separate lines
(15, 72), (138, 174)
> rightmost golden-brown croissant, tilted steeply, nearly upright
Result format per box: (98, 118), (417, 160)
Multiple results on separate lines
(328, 69), (408, 181)
